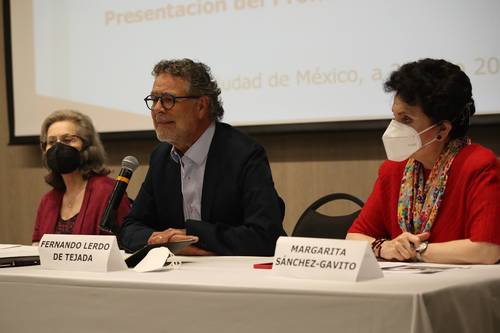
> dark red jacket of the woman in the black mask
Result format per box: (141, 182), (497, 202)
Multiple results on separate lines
(32, 176), (130, 242)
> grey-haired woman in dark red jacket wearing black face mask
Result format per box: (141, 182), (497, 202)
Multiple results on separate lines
(32, 110), (130, 244)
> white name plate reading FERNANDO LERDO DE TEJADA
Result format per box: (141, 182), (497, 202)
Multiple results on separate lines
(38, 234), (127, 272)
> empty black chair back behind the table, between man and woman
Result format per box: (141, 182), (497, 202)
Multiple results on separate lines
(292, 193), (364, 239)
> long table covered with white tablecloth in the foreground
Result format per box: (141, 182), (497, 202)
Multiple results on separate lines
(0, 250), (500, 333)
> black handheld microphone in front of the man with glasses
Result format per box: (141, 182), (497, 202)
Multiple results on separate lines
(99, 156), (139, 235)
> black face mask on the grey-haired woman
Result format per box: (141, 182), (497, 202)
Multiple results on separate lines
(47, 142), (80, 175)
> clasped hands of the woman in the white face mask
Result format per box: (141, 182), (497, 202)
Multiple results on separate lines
(380, 232), (431, 261)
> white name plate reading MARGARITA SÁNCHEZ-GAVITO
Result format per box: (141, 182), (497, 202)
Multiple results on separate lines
(273, 237), (384, 282)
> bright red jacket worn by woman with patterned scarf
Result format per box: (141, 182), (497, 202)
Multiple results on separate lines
(349, 144), (500, 245)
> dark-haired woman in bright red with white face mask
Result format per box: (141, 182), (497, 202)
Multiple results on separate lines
(347, 59), (500, 264)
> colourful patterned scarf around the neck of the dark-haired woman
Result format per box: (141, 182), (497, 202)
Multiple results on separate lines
(398, 137), (470, 234)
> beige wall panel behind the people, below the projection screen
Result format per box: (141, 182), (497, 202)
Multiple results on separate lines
(0, 8), (500, 244)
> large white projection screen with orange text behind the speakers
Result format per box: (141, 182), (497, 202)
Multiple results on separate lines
(6, 0), (500, 143)
